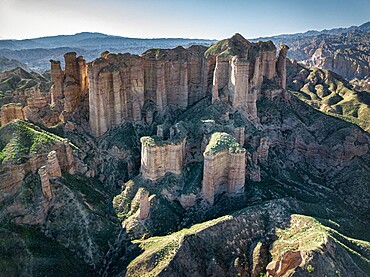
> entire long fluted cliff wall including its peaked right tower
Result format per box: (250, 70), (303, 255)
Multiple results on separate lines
(88, 34), (288, 136)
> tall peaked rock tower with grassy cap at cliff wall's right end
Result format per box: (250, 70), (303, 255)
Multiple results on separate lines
(205, 34), (276, 122)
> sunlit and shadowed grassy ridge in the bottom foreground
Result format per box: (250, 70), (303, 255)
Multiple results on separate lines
(125, 201), (366, 276)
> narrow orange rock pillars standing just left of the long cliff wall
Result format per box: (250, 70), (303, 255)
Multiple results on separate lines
(50, 52), (88, 113)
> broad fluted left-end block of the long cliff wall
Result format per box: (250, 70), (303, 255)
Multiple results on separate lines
(88, 54), (144, 136)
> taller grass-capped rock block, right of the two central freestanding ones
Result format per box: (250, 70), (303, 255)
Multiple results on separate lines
(202, 133), (246, 205)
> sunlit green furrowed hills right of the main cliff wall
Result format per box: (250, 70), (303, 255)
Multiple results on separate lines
(287, 62), (370, 131)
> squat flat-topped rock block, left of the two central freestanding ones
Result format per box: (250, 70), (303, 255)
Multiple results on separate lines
(140, 124), (186, 180)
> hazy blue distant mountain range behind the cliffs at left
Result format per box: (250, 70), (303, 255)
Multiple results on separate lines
(0, 32), (215, 73)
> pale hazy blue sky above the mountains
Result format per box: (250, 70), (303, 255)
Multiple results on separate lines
(0, 0), (370, 39)
